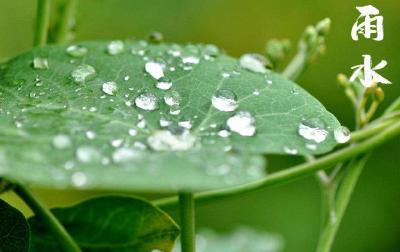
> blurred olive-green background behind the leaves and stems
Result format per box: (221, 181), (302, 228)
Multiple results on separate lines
(0, 0), (400, 252)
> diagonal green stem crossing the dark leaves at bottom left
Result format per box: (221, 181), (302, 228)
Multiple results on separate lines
(14, 185), (81, 252)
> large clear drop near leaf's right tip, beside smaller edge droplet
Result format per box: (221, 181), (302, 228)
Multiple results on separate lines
(298, 119), (328, 143)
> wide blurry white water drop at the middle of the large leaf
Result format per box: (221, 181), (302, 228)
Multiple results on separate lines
(147, 130), (196, 151)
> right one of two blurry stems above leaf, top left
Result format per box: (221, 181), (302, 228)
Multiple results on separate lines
(54, 0), (78, 43)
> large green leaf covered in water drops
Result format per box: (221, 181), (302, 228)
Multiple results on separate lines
(0, 42), (339, 190)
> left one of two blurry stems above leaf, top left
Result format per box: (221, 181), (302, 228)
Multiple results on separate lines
(33, 0), (50, 46)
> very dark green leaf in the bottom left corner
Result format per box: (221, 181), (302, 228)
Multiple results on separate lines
(0, 199), (29, 252)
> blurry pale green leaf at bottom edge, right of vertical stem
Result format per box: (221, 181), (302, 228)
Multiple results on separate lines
(173, 227), (284, 252)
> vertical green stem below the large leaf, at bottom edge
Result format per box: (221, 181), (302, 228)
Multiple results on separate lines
(179, 192), (196, 252)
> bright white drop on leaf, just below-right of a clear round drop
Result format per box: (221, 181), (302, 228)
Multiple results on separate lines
(226, 111), (256, 136)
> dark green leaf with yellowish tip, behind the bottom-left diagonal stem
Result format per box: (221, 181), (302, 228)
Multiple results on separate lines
(29, 196), (179, 252)
